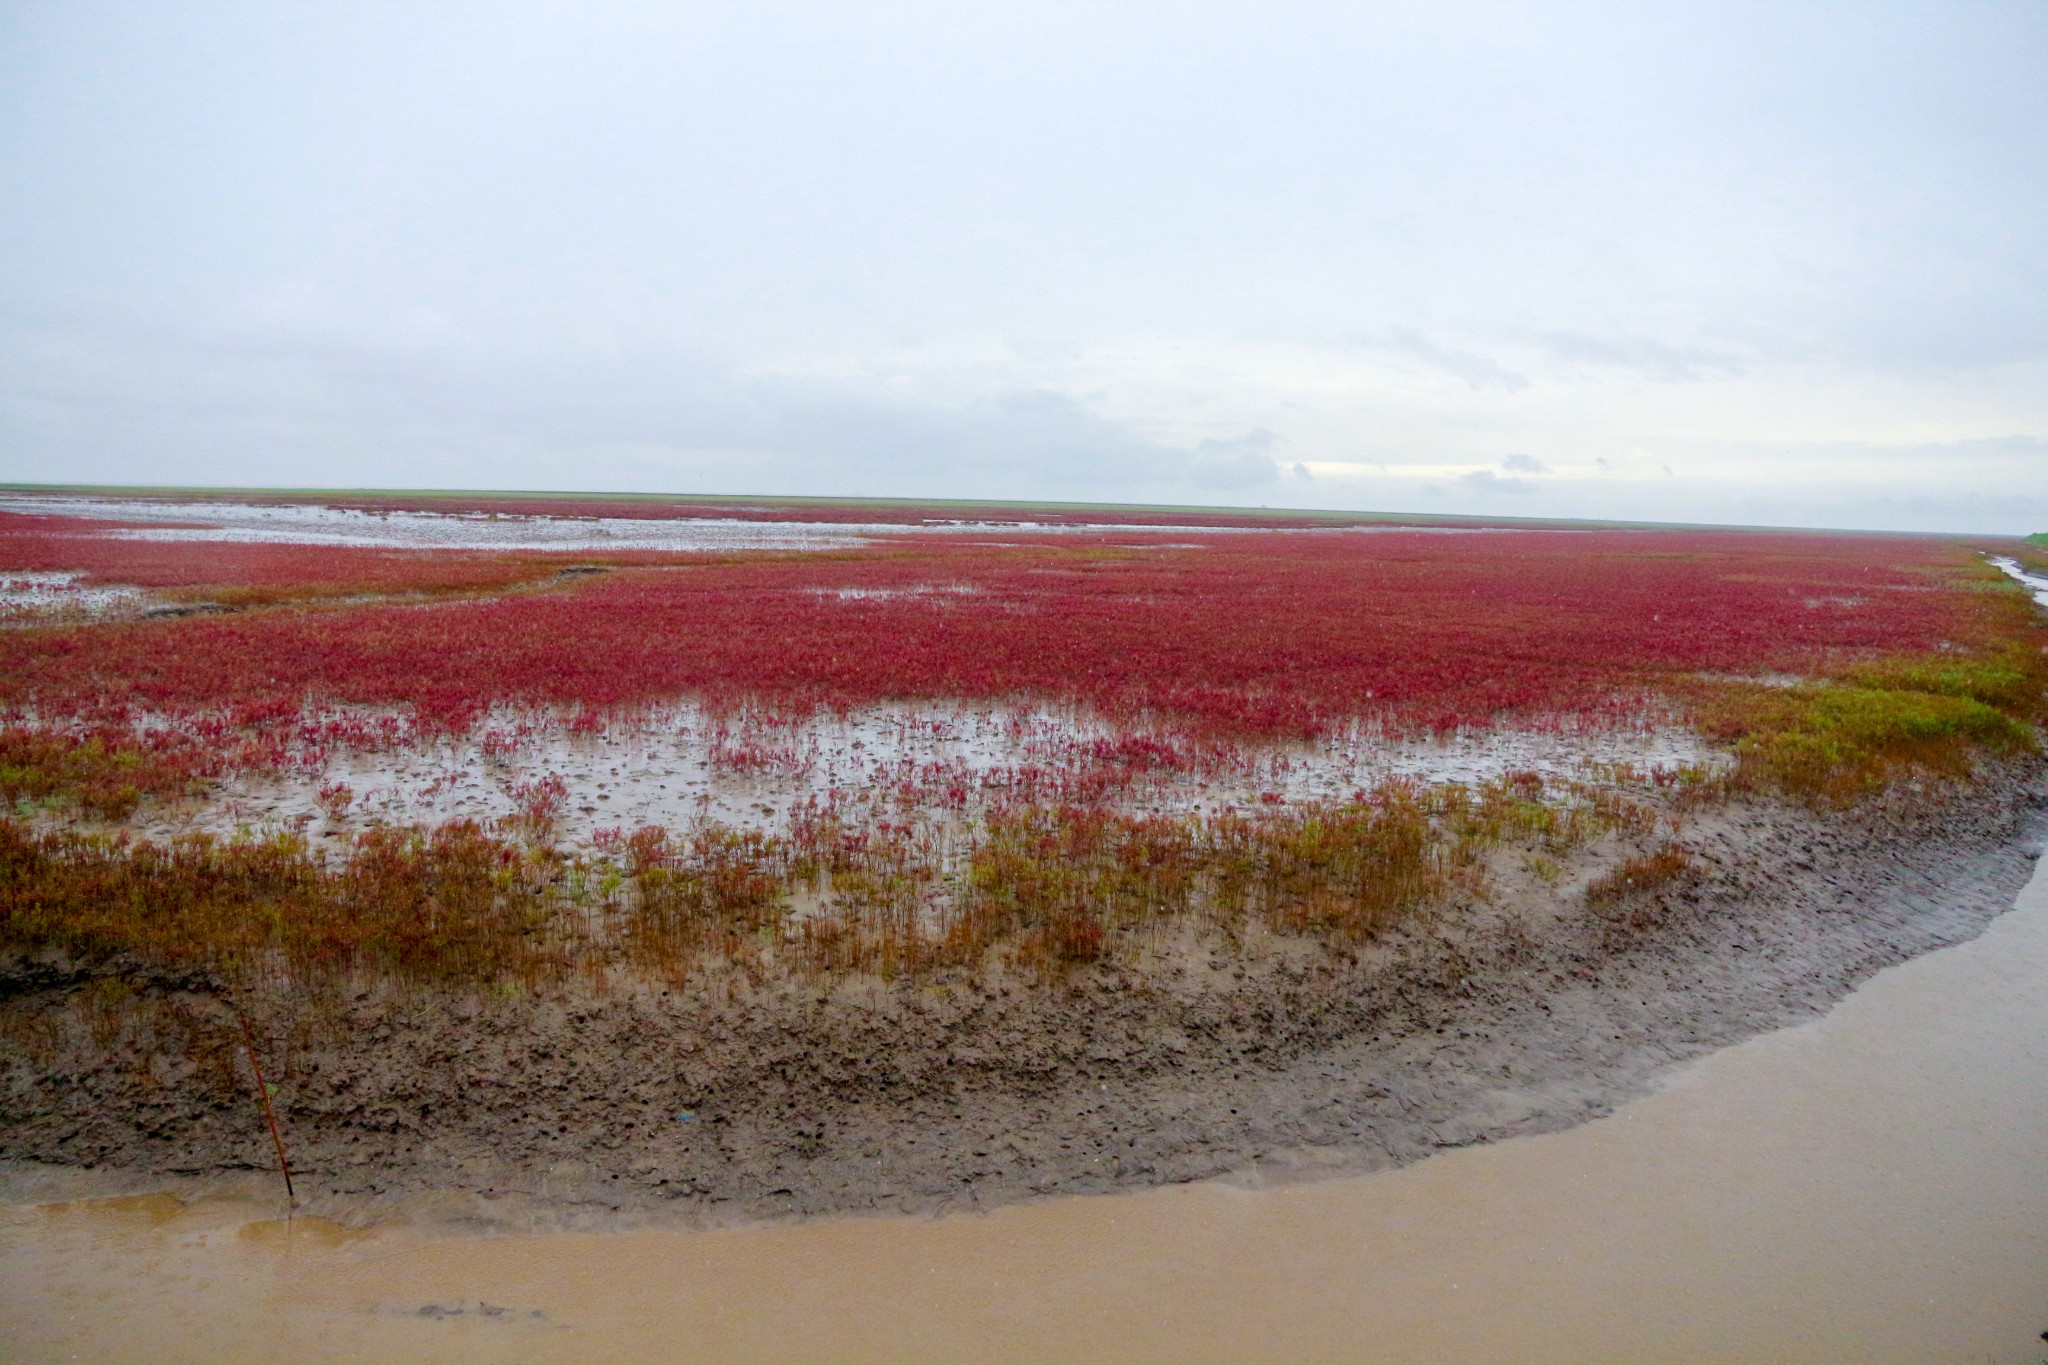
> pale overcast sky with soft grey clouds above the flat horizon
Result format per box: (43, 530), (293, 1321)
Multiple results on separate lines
(0, 0), (2048, 532)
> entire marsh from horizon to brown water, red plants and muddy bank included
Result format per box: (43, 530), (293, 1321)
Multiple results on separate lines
(0, 493), (2048, 1218)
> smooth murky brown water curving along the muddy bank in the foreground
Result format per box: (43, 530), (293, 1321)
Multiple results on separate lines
(0, 859), (2048, 1365)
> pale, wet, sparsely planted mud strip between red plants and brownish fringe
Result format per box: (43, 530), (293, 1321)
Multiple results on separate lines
(159, 706), (1733, 849)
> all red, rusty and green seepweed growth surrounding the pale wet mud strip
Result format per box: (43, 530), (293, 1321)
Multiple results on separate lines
(0, 507), (2044, 998)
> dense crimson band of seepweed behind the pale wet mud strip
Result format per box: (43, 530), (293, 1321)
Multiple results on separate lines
(0, 532), (2015, 739)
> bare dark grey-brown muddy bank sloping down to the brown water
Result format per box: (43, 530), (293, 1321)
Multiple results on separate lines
(0, 763), (2048, 1224)
